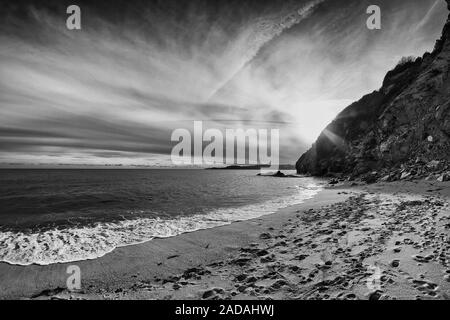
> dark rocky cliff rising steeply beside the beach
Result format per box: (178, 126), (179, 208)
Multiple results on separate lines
(296, 0), (450, 178)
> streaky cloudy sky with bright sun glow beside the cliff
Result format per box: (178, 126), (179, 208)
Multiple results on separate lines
(0, 0), (448, 167)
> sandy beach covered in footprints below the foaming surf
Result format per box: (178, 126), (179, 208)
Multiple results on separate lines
(0, 181), (450, 299)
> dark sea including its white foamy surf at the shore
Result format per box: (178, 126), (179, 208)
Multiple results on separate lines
(0, 169), (324, 265)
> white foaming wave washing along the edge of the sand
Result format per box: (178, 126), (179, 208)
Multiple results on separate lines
(0, 184), (322, 265)
